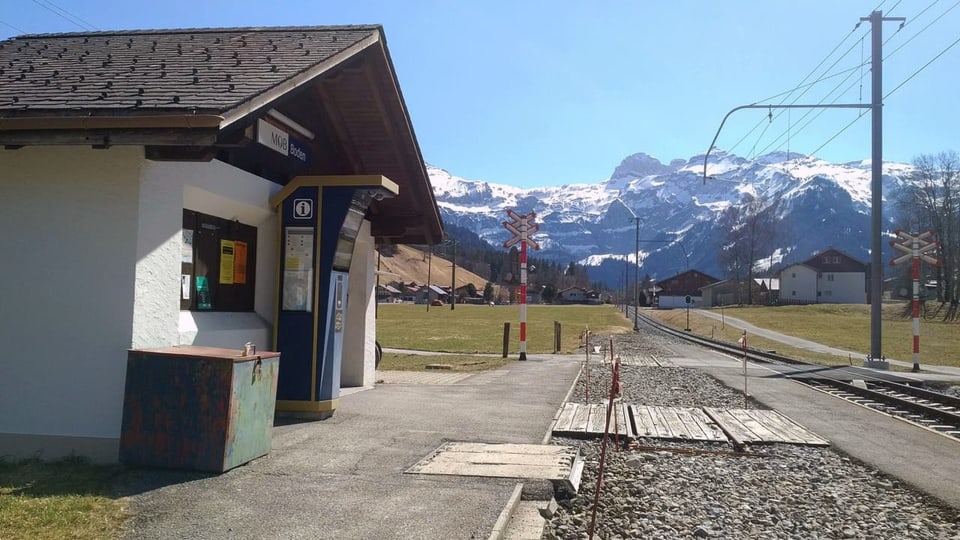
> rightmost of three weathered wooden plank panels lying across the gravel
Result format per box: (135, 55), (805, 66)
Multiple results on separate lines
(704, 407), (830, 446)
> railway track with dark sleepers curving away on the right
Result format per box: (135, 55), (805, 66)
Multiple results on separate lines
(631, 313), (960, 440)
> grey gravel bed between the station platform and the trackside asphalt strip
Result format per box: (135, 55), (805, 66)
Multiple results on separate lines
(543, 326), (960, 540)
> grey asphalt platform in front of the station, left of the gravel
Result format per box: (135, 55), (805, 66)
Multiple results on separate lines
(119, 354), (582, 539)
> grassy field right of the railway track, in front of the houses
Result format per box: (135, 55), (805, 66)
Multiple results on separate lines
(645, 304), (960, 367)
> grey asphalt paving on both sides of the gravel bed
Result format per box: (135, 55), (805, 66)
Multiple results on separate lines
(118, 317), (960, 539)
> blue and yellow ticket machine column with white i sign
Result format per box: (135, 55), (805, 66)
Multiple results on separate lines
(271, 176), (398, 419)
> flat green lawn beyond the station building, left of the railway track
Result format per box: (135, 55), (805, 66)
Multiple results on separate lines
(377, 304), (633, 354)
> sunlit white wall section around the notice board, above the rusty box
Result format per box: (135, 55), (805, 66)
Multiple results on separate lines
(134, 161), (280, 350)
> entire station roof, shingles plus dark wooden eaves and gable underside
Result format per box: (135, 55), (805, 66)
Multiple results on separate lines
(0, 25), (443, 244)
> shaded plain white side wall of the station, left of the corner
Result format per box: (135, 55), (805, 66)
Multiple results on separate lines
(0, 146), (144, 459)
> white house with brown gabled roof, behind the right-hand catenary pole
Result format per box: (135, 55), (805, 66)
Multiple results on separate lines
(780, 248), (867, 304)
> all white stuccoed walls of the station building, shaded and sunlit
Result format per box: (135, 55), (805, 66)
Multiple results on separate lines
(0, 146), (386, 462)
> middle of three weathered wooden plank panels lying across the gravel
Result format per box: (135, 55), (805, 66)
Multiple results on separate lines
(629, 405), (727, 442)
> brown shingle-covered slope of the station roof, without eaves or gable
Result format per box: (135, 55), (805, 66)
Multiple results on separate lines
(0, 25), (382, 116)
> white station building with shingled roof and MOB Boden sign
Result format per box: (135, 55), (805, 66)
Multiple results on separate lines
(0, 25), (444, 462)
